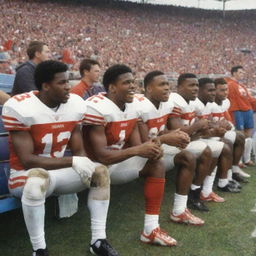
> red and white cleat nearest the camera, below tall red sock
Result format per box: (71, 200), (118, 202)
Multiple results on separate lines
(140, 227), (177, 246)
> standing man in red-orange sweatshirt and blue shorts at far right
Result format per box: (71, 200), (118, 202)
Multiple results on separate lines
(226, 66), (256, 165)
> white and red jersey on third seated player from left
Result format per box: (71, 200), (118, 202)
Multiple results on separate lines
(131, 95), (173, 138)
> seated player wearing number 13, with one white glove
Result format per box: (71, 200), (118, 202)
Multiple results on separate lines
(3, 61), (118, 256)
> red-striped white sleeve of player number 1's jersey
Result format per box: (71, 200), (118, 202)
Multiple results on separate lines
(83, 104), (106, 126)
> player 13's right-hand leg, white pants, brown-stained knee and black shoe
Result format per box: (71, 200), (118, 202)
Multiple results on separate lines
(50, 164), (118, 256)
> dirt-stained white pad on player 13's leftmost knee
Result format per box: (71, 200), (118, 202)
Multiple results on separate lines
(23, 168), (50, 201)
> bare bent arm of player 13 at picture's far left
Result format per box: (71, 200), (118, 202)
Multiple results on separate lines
(10, 131), (72, 170)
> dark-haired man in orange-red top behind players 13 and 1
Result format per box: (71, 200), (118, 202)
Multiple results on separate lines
(71, 59), (105, 100)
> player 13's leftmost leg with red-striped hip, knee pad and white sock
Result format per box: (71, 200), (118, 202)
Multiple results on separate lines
(9, 168), (50, 256)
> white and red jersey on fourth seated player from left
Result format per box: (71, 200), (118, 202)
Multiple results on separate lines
(168, 93), (196, 126)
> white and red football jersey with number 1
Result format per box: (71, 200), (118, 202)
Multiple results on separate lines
(84, 93), (139, 149)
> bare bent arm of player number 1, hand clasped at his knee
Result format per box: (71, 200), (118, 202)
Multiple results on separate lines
(84, 125), (160, 165)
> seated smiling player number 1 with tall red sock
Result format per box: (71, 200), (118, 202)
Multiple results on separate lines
(83, 65), (176, 246)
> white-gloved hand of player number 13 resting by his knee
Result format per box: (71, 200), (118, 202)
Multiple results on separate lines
(72, 156), (96, 185)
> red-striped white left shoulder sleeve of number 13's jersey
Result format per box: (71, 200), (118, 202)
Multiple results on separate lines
(2, 99), (30, 131)
